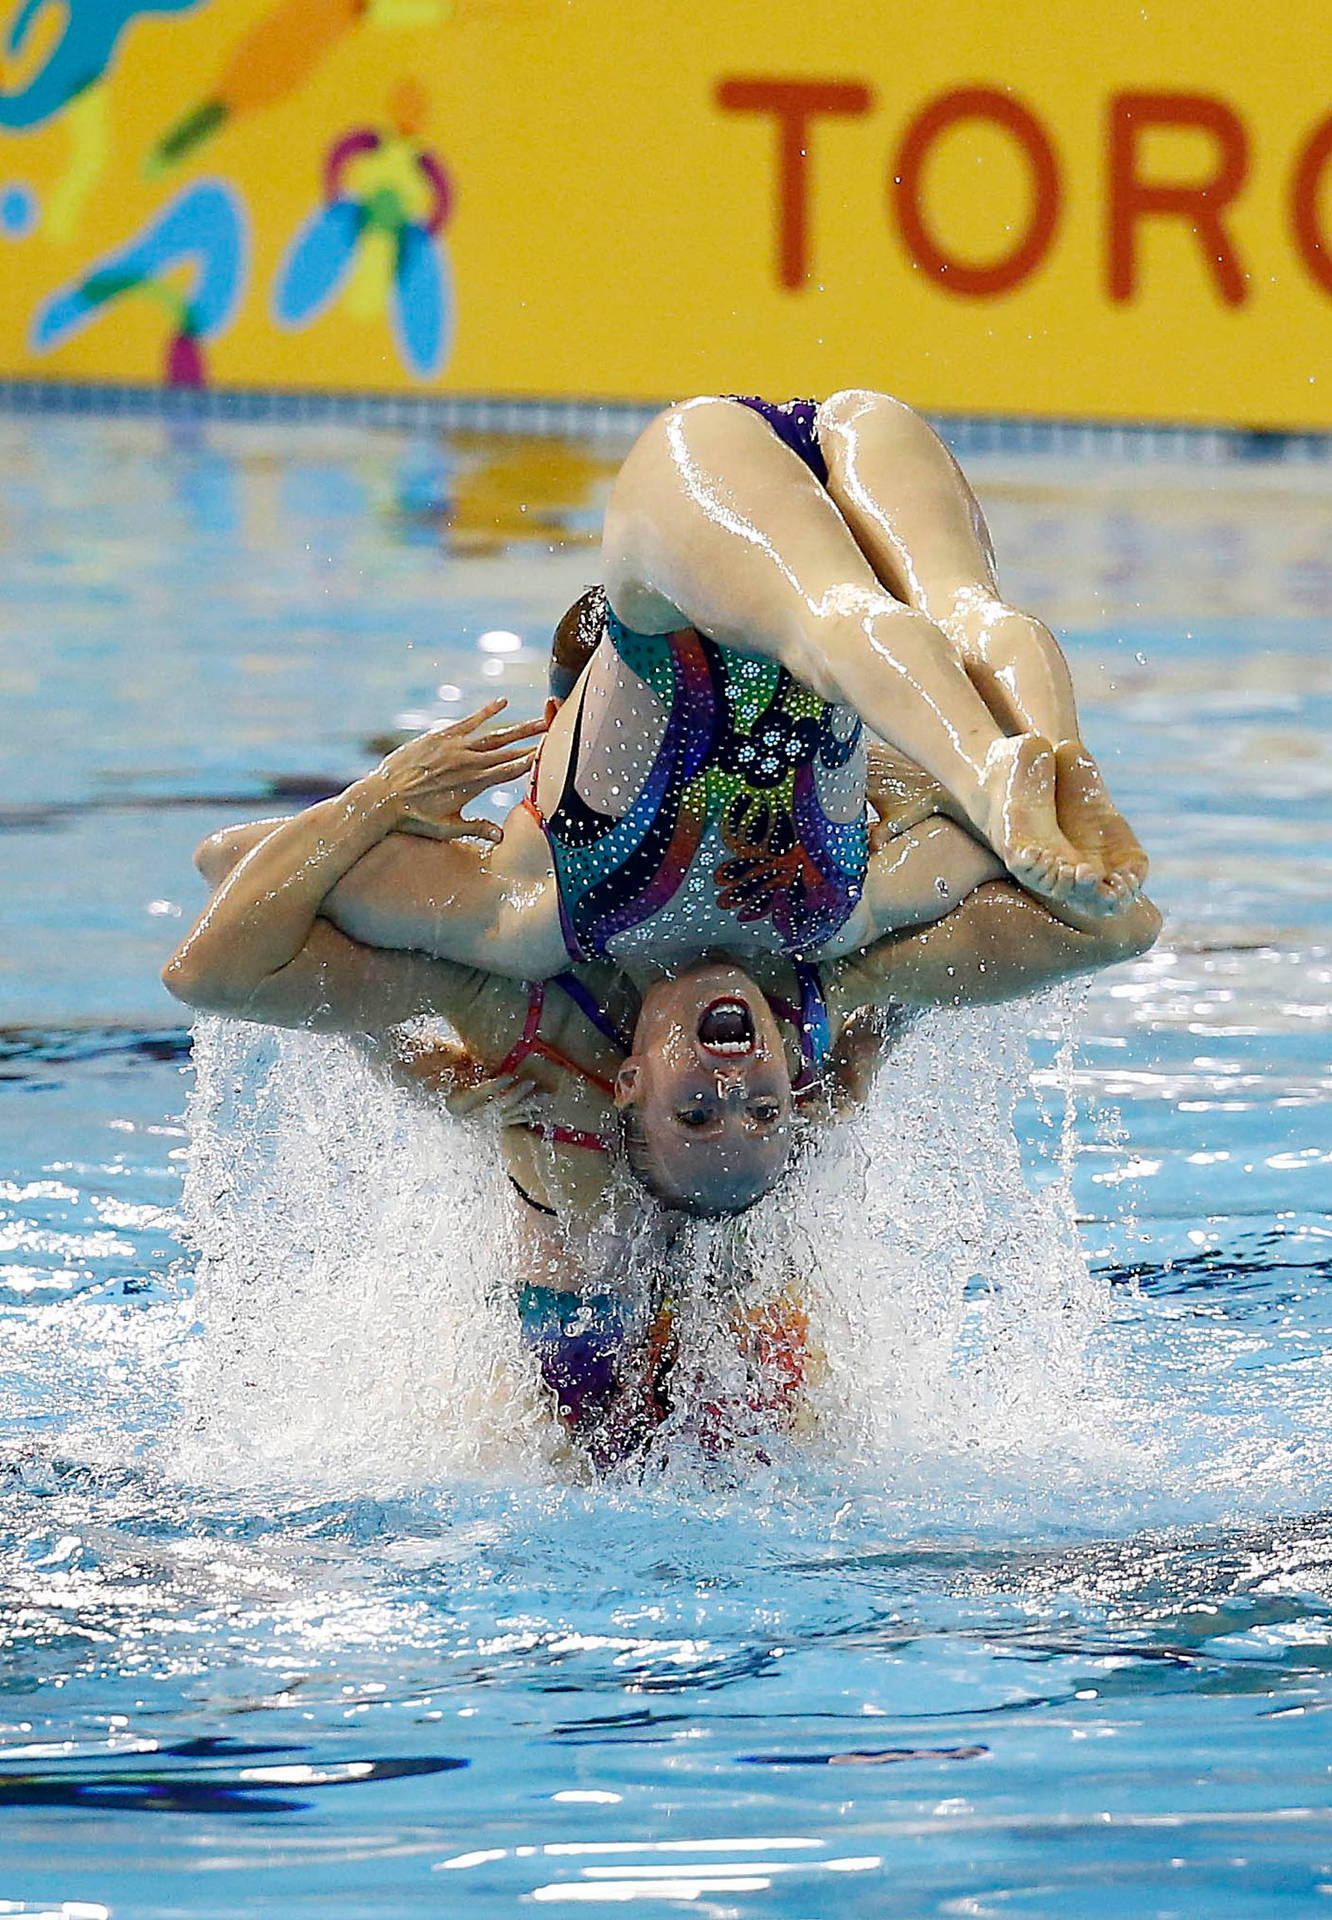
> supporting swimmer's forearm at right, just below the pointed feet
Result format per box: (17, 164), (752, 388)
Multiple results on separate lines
(829, 881), (1161, 1018)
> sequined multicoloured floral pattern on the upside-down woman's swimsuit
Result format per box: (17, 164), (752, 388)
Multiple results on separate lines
(543, 609), (869, 958)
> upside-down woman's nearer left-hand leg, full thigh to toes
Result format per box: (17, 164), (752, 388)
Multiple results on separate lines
(603, 399), (1096, 900)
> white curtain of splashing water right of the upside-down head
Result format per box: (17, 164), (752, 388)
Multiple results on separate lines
(798, 996), (1109, 1459)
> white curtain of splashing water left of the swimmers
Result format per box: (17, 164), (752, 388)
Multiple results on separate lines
(184, 1020), (545, 1484)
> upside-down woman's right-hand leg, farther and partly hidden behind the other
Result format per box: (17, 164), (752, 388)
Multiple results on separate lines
(818, 390), (1148, 904)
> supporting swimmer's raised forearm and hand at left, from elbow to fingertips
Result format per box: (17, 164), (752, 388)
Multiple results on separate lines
(163, 701), (534, 1020)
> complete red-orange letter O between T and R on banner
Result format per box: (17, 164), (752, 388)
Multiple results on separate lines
(892, 86), (1059, 300)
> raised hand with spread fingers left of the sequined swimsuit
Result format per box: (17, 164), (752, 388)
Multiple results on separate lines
(365, 699), (545, 841)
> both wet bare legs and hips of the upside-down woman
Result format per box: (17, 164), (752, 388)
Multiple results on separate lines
(603, 390), (1146, 912)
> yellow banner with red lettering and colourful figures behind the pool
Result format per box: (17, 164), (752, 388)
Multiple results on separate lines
(0, 0), (1332, 428)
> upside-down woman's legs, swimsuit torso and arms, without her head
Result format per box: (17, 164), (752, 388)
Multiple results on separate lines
(303, 392), (1146, 977)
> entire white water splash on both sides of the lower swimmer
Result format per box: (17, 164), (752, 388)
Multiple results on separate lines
(184, 998), (1106, 1480)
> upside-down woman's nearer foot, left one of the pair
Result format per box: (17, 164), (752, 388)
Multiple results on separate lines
(981, 733), (1117, 914)
